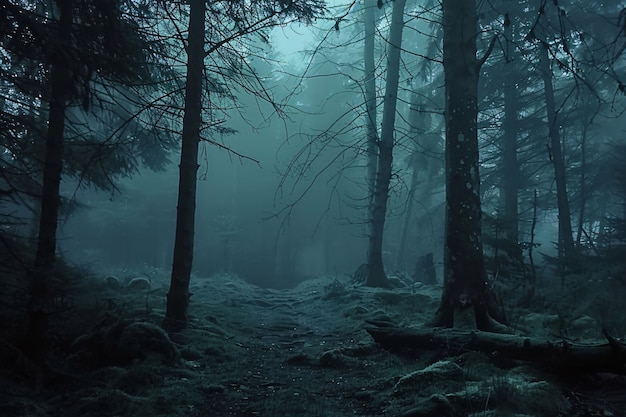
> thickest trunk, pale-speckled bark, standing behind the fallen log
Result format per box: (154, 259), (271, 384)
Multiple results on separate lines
(433, 0), (492, 330)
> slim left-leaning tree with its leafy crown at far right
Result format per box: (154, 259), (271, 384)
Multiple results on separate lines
(526, 1), (619, 266)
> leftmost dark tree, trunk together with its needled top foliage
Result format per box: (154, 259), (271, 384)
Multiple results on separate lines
(0, 0), (148, 388)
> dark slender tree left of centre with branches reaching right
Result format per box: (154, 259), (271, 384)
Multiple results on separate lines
(163, 0), (324, 331)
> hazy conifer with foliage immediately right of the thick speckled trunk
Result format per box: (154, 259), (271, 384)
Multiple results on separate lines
(478, 3), (532, 290)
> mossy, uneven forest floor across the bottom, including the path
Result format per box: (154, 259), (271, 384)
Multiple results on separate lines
(0, 271), (626, 417)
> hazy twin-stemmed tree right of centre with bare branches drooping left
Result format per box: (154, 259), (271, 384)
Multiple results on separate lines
(264, 2), (437, 287)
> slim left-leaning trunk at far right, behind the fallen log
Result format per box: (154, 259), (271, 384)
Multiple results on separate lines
(539, 42), (574, 263)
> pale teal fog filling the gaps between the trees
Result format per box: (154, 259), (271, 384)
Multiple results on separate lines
(52, 0), (576, 288)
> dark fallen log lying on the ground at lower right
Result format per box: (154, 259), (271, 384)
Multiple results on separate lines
(366, 322), (626, 375)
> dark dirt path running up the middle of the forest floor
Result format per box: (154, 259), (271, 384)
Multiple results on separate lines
(188, 282), (388, 417)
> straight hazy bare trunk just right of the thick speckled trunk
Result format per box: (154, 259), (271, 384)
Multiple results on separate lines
(502, 16), (521, 250)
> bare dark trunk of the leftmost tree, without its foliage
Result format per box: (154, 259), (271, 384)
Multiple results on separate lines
(25, 1), (73, 390)
